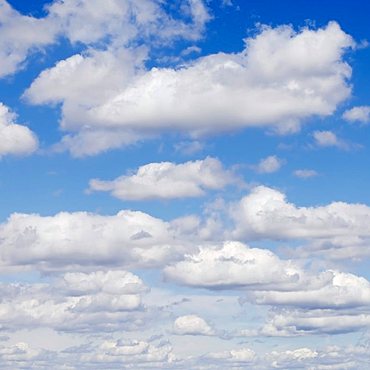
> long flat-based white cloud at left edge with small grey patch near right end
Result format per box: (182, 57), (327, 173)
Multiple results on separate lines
(0, 211), (193, 270)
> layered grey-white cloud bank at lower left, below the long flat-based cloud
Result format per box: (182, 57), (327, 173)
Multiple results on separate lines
(0, 270), (147, 332)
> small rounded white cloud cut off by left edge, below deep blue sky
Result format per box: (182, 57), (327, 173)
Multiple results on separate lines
(0, 103), (38, 157)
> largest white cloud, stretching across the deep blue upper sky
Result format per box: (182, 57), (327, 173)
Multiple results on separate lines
(25, 22), (354, 155)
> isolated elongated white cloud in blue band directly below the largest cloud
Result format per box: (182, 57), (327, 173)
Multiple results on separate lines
(89, 157), (236, 200)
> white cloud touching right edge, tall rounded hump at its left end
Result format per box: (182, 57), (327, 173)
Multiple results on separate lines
(231, 186), (370, 242)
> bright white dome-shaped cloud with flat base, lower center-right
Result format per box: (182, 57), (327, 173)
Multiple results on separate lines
(164, 242), (303, 290)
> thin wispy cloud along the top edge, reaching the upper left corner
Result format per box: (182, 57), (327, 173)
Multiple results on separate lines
(0, 0), (211, 78)
